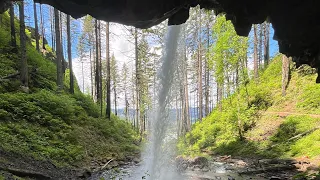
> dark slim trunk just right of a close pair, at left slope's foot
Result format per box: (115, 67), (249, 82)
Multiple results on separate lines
(106, 22), (111, 120)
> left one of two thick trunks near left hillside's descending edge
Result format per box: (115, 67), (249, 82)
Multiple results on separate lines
(54, 8), (63, 91)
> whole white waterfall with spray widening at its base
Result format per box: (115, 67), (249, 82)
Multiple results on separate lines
(97, 26), (183, 180)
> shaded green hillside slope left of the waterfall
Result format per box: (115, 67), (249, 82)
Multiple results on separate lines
(0, 13), (139, 179)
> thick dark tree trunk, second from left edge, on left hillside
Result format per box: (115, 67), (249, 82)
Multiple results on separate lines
(19, 1), (28, 91)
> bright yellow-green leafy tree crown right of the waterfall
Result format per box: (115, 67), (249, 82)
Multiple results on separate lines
(207, 15), (248, 93)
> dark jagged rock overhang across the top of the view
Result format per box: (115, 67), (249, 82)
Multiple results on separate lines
(0, 0), (320, 75)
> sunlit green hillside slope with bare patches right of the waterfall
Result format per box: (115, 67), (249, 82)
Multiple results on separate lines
(179, 55), (320, 169)
